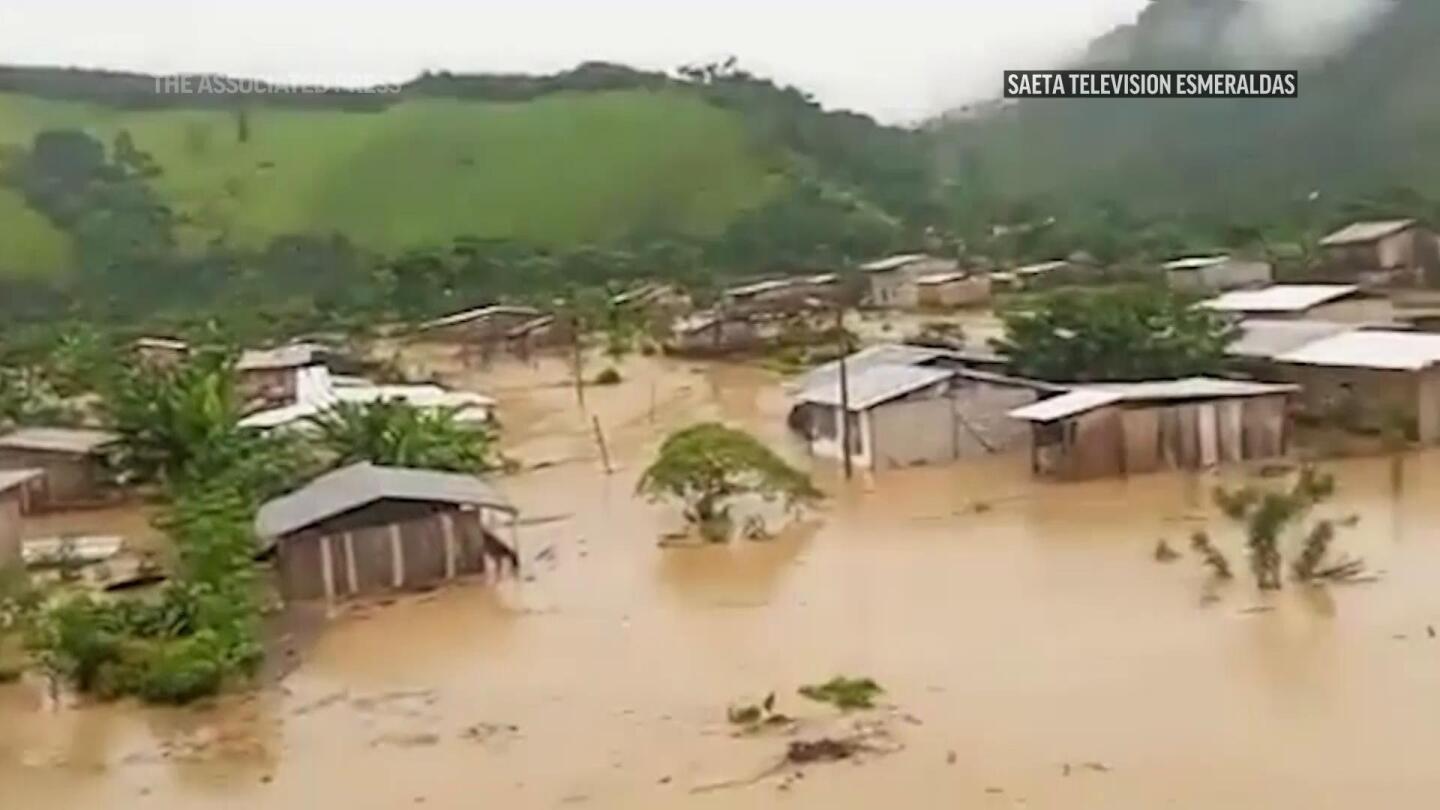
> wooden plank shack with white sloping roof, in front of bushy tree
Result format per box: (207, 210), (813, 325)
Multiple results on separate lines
(1009, 378), (1296, 480)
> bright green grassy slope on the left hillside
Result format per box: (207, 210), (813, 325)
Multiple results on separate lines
(0, 91), (779, 262)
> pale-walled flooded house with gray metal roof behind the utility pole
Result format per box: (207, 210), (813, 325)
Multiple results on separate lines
(789, 344), (1056, 470)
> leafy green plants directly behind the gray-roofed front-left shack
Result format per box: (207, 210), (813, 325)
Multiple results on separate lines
(311, 399), (501, 473)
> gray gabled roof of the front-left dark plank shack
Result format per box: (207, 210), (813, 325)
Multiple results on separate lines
(255, 463), (516, 538)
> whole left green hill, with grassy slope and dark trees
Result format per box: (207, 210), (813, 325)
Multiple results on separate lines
(0, 63), (935, 295)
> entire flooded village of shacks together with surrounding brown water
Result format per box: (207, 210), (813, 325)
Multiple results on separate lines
(0, 221), (1440, 810)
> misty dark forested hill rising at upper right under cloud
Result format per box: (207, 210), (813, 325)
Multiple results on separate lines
(939, 0), (1440, 246)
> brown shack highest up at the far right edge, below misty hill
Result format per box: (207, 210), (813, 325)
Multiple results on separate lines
(1320, 219), (1440, 285)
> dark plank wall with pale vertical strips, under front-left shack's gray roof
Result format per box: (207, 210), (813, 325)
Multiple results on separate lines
(276, 507), (512, 601)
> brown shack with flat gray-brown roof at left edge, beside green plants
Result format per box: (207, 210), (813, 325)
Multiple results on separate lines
(0, 428), (120, 510)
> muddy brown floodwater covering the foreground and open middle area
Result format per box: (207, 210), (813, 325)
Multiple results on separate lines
(0, 353), (1440, 810)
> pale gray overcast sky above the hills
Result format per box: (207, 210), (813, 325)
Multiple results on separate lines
(0, 0), (1145, 121)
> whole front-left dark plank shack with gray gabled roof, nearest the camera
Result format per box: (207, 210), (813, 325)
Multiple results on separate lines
(255, 463), (520, 602)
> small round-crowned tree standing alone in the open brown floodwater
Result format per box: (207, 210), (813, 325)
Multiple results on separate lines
(635, 422), (821, 540)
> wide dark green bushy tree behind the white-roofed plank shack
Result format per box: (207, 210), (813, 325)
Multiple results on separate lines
(995, 287), (1236, 382)
